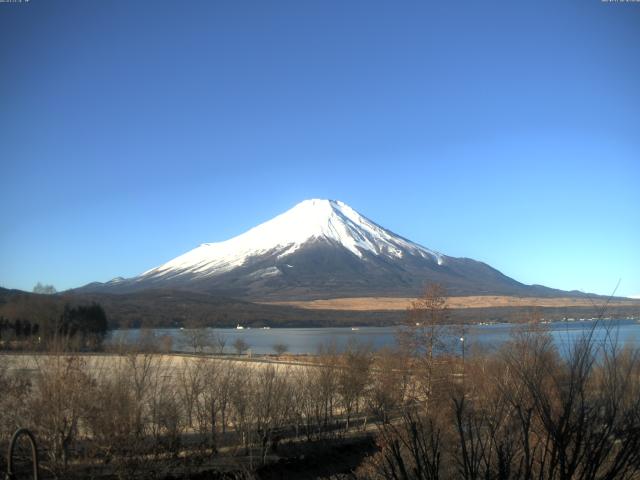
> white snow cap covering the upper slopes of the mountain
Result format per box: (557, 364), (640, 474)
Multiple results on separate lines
(136, 199), (444, 281)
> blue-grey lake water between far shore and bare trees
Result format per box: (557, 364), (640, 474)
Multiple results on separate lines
(107, 319), (640, 354)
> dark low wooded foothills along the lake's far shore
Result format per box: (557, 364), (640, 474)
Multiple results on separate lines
(0, 290), (640, 328)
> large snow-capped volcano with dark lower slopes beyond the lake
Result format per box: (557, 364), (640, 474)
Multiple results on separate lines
(78, 199), (577, 300)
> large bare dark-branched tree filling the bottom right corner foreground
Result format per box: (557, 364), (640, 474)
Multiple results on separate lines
(508, 325), (640, 479)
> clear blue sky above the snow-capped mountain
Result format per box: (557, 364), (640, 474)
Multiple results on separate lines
(0, 0), (640, 295)
